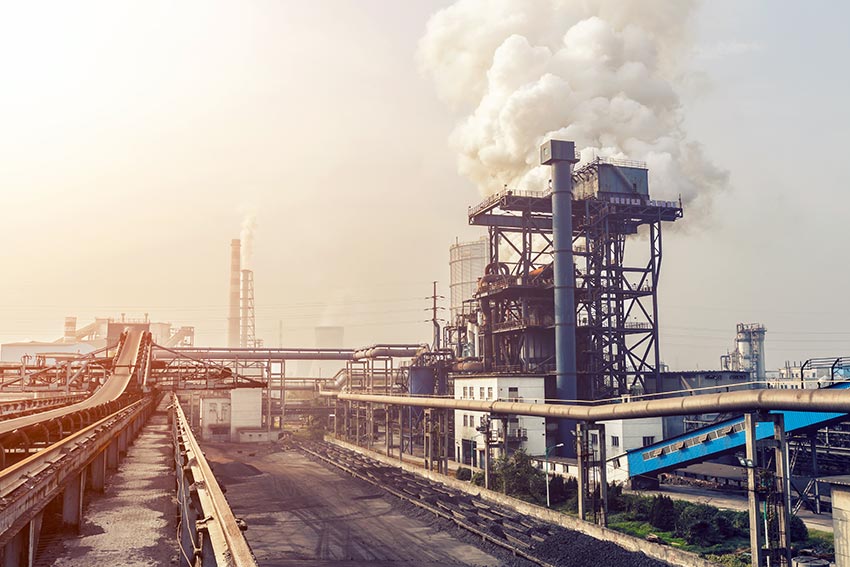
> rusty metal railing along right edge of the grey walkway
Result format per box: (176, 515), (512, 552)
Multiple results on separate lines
(171, 394), (257, 567)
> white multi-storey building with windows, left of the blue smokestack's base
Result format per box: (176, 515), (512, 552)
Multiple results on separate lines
(454, 374), (546, 467)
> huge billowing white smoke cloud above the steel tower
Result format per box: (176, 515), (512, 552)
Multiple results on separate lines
(419, 0), (728, 215)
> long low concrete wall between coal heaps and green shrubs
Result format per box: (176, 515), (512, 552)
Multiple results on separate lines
(325, 436), (719, 567)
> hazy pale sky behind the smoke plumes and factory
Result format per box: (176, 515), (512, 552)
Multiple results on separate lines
(0, 0), (850, 368)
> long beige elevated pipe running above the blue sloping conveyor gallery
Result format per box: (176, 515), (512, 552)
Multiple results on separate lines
(321, 388), (850, 421)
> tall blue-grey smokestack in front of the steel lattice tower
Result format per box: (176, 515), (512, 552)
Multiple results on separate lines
(540, 140), (578, 457)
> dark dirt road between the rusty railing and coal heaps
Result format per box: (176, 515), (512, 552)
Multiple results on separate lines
(204, 444), (503, 567)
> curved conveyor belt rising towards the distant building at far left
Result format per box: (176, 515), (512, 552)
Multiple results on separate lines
(0, 330), (144, 435)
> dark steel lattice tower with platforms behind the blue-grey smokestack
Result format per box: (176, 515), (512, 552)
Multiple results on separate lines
(468, 159), (682, 400)
